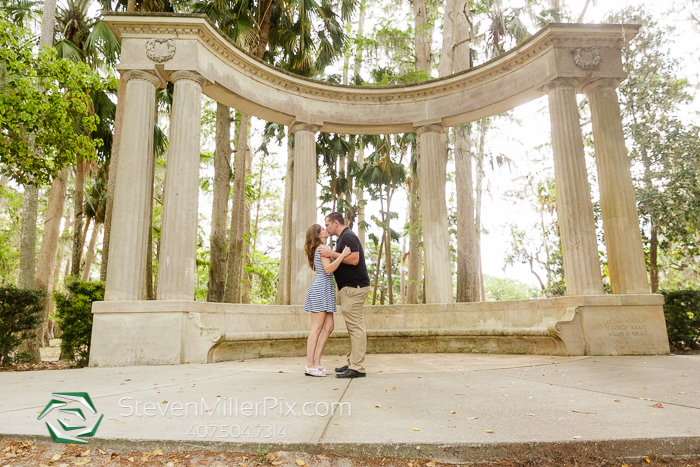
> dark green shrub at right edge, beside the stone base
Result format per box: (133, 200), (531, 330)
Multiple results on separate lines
(660, 289), (700, 349)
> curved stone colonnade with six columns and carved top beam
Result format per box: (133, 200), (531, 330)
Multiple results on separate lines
(105, 15), (649, 305)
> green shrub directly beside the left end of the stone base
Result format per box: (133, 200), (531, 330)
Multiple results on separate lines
(53, 277), (105, 367)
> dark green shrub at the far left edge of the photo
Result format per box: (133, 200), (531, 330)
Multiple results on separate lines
(0, 285), (46, 365)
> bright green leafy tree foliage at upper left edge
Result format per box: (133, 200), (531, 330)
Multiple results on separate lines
(0, 16), (112, 184)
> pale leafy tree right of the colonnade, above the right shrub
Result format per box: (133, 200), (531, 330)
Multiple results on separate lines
(609, 6), (700, 291)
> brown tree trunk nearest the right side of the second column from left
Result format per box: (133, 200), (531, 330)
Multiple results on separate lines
(207, 102), (231, 302)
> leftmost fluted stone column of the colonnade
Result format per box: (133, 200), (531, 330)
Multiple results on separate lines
(105, 70), (160, 300)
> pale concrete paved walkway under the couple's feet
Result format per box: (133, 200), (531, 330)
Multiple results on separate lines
(0, 354), (700, 460)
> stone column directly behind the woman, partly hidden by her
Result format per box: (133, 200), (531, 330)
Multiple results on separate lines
(289, 123), (318, 305)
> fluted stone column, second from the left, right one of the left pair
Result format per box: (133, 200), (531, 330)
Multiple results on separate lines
(157, 71), (205, 300)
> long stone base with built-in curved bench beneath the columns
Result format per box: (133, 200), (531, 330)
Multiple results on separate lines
(90, 295), (669, 366)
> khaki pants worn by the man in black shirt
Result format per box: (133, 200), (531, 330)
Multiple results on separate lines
(338, 286), (369, 373)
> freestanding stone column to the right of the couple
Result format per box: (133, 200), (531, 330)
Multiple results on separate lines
(416, 125), (454, 303)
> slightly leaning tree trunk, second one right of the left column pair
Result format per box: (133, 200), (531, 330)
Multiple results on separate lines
(224, 113), (249, 303)
